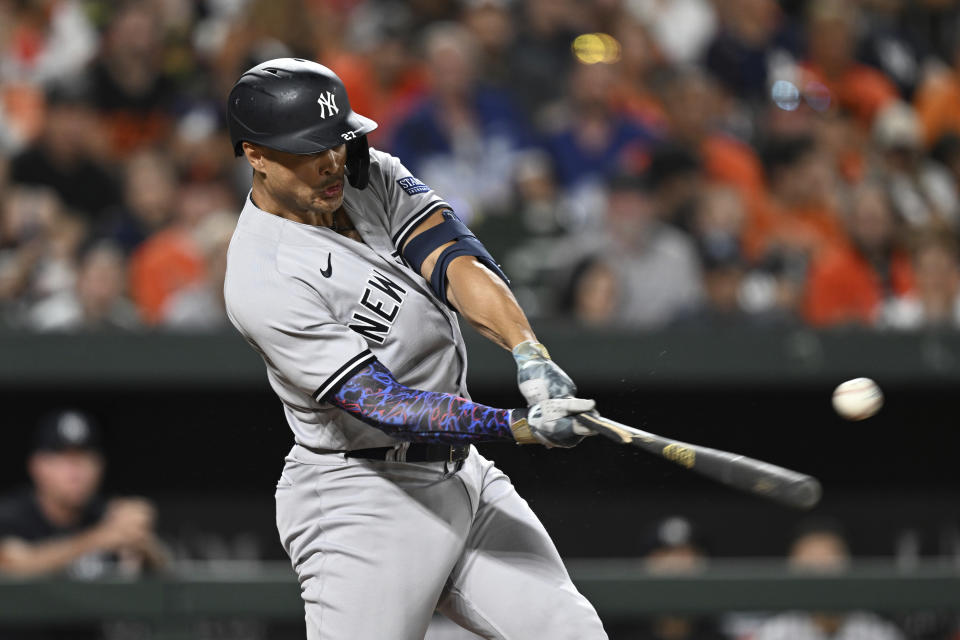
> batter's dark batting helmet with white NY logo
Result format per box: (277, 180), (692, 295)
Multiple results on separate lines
(227, 58), (377, 189)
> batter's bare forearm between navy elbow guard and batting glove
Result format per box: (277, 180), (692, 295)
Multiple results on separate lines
(447, 256), (537, 350)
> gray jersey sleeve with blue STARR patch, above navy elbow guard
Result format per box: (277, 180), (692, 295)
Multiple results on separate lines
(370, 149), (452, 250)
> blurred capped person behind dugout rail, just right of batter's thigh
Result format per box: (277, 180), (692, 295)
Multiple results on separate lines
(608, 515), (726, 640)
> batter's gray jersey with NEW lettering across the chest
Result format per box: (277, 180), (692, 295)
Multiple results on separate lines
(224, 149), (469, 449)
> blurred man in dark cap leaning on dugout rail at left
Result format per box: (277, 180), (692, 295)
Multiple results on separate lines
(0, 411), (164, 579)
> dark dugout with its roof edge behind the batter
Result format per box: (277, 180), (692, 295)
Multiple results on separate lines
(0, 328), (960, 560)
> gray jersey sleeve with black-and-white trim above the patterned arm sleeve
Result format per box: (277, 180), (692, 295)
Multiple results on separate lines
(231, 275), (375, 402)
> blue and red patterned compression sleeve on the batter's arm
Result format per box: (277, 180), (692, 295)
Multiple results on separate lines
(326, 361), (514, 444)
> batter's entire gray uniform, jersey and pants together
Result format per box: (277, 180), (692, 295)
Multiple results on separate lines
(224, 150), (606, 640)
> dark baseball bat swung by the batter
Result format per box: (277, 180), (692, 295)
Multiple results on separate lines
(577, 413), (822, 509)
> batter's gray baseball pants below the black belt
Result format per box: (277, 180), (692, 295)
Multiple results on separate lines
(276, 446), (607, 640)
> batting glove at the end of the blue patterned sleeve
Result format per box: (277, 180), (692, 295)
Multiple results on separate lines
(510, 398), (597, 448)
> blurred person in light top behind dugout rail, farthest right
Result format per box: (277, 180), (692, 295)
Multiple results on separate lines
(753, 520), (904, 640)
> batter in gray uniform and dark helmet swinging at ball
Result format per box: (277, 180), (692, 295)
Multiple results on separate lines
(224, 58), (607, 640)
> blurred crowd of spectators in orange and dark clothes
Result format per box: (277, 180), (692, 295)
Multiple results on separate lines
(0, 0), (960, 330)
